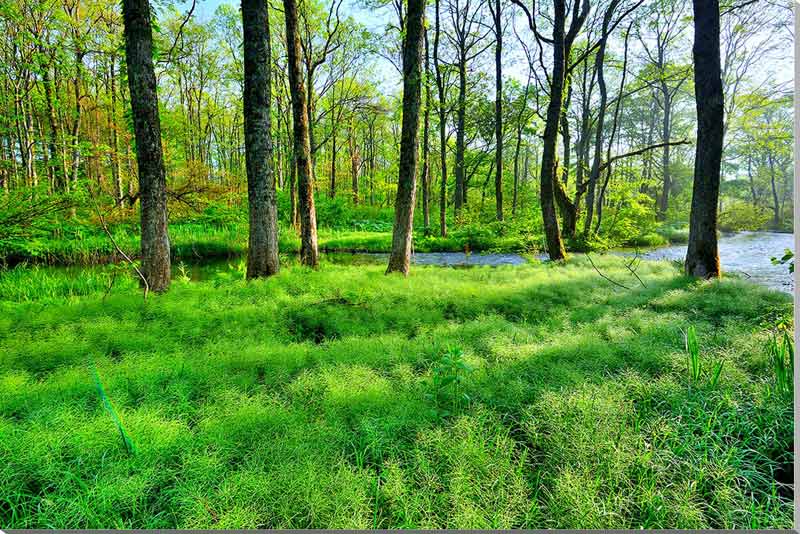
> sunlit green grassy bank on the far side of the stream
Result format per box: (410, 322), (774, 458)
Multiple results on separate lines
(0, 220), (688, 266)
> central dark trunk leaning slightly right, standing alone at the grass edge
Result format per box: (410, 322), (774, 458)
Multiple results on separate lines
(386, 0), (425, 275)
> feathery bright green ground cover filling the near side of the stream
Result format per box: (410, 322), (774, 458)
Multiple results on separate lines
(0, 257), (793, 528)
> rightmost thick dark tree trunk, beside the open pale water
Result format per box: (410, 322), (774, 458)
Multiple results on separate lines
(685, 0), (724, 278)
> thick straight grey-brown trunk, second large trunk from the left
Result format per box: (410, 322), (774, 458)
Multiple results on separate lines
(242, 0), (279, 280)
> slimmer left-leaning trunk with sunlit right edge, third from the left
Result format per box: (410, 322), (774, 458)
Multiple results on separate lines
(283, 0), (319, 268)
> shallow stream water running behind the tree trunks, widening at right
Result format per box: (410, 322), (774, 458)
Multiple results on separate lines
(167, 232), (794, 293)
